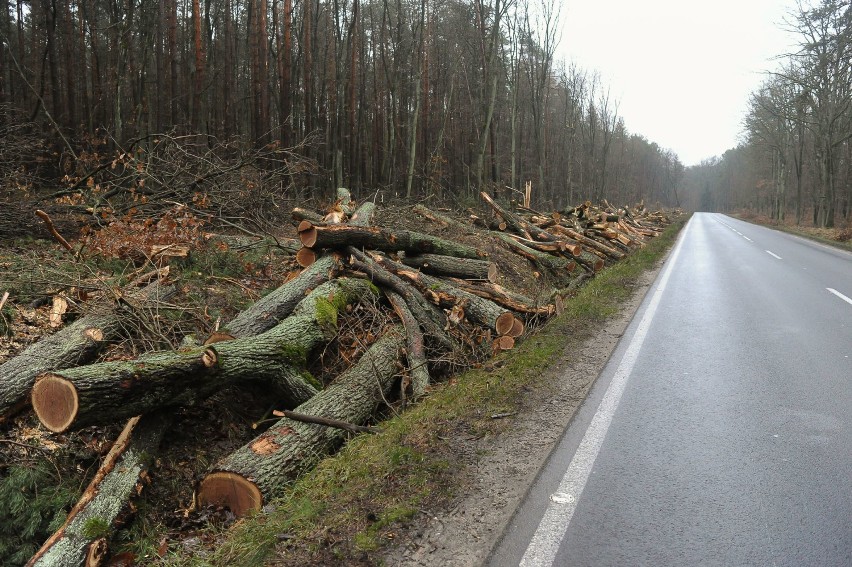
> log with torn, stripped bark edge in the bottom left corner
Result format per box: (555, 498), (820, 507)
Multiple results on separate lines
(27, 414), (170, 567)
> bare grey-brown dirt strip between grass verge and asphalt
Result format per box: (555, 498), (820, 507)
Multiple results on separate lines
(381, 263), (662, 567)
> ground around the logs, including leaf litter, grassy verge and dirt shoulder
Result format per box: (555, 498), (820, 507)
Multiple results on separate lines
(0, 202), (685, 565)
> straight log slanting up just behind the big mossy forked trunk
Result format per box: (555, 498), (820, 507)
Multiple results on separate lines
(222, 256), (341, 338)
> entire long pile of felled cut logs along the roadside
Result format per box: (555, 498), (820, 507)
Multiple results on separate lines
(0, 190), (669, 565)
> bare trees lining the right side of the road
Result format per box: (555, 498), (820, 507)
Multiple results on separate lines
(685, 0), (852, 227)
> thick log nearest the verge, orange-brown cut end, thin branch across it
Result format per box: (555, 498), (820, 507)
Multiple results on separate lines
(198, 328), (405, 516)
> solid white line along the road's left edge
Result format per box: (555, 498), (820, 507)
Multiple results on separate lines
(520, 221), (692, 567)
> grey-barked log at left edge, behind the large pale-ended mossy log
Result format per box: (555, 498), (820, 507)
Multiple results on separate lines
(0, 281), (175, 422)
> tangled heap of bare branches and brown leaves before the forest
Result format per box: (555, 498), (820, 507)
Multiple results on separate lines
(43, 133), (317, 229)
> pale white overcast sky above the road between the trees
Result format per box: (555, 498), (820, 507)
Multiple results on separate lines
(556, 0), (796, 166)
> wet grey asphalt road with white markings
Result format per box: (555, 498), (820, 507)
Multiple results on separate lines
(489, 213), (852, 567)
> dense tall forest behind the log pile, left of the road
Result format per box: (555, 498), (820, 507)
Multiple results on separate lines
(0, 0), (684, 211)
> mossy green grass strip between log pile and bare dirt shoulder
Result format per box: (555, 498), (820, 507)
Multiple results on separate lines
(162, 216), (688, 566)
